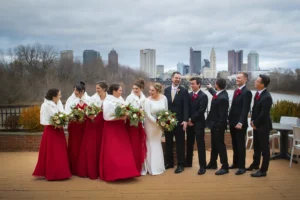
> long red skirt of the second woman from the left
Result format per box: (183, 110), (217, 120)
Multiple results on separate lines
(68, 122), (85, 175)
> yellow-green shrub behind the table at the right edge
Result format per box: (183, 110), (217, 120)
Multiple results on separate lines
(271, 100), (300, 122)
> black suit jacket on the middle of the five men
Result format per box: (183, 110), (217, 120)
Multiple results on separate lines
(206, 88), (229, 130)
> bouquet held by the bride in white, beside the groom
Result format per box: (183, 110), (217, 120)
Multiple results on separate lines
(156, 110), (178, 131)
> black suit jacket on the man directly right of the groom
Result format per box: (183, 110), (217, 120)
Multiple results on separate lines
(189, 90), (208, 128)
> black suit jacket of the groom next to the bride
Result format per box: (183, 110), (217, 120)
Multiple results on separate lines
(165, 86), (189, 122)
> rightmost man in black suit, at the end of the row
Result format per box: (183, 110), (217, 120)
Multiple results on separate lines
(247, 75), (273, 177)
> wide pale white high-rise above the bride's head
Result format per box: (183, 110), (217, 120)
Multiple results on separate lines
(140, 49), (157, 78)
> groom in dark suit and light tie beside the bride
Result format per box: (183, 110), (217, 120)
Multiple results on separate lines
(165, 72), (189, 173)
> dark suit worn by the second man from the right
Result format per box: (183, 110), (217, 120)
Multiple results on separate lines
(228, 86), (252, 169)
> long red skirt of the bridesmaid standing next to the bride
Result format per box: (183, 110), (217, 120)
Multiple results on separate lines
(127, 122), (147, 172)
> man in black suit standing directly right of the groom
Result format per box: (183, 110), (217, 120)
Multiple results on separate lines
(185, 77), (208, 175)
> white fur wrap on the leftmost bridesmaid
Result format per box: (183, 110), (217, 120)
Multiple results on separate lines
(40, 99), (64, 125)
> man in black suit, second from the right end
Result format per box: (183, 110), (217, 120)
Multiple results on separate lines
(228, 72), (252, 175)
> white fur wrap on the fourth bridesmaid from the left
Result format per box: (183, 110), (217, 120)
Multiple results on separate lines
(103, 95), (125, 121)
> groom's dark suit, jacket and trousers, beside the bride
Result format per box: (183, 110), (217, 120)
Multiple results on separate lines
(165, 86), (189, 166)
